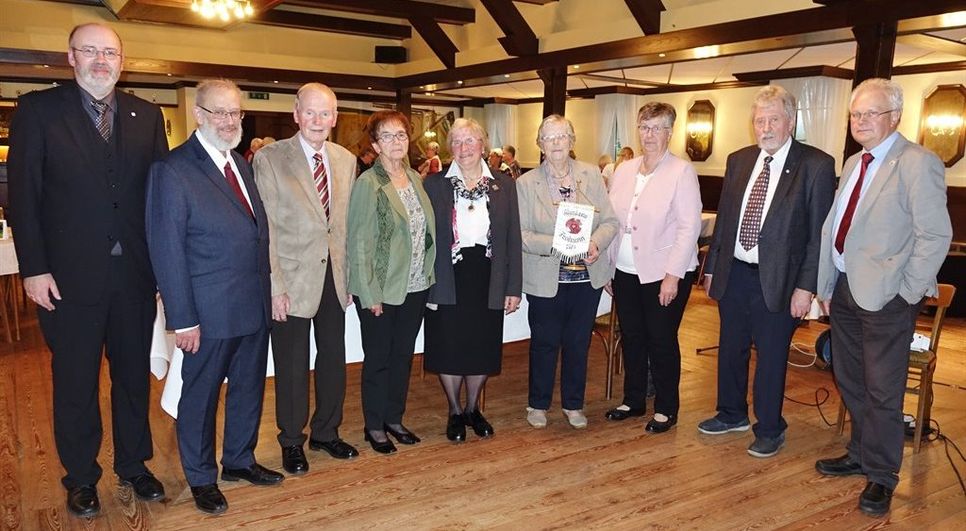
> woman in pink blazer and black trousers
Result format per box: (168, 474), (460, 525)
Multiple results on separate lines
(606, 102), (701, 433)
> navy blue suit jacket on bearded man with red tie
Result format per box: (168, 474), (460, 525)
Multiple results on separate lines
(147, 132), (272, 339)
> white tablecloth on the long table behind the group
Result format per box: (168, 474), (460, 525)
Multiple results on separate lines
(151, 292), (611, 418)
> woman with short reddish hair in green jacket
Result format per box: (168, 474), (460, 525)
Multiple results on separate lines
(348, 111), (436, 454)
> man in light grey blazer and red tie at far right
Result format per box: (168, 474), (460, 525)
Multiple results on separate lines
(815, 78), (952, 516)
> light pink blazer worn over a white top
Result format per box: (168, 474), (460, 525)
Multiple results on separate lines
(609, 153), (701, 284)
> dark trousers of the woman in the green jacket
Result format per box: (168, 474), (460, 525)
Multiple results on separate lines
(355, 290), (429, 431)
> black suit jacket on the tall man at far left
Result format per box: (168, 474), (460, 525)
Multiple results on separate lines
(9, 83), (168, 304)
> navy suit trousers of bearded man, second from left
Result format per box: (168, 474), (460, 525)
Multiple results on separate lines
(176, 327), (268, 487)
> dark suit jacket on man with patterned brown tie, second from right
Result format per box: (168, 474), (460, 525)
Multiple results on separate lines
(705, 140), (835, 312)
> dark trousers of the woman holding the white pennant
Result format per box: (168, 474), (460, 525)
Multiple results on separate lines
(527, 282), (601, 409)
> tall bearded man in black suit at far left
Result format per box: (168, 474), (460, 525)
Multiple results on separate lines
(9, 24), (168, 516)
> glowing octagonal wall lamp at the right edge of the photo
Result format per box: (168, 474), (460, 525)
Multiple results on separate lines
(919, 85), (966, 168)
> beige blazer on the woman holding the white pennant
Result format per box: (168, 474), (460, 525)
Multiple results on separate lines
(516, 161), (620, 297)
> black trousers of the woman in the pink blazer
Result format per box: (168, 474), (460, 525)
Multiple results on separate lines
(612, 270), (694, 416)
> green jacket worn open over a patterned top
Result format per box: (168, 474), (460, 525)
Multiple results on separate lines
(347, 160), (436, 308)
